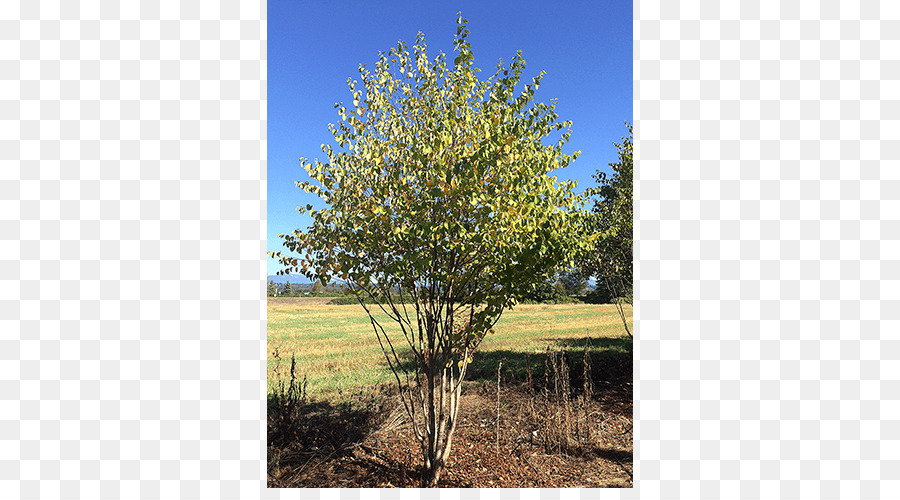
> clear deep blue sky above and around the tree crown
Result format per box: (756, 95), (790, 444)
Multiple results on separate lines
(267, 0), (633, 281)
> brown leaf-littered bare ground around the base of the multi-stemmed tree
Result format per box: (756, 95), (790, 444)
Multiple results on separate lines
(268, 348), (634, 488)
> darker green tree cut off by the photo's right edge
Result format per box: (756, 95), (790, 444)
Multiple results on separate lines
(579, 122), (634, 336)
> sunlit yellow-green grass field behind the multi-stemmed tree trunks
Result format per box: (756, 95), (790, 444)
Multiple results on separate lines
(267, 298), (631, 396)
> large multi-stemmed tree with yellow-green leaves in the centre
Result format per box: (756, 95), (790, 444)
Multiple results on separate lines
(272, 16), (585, 485)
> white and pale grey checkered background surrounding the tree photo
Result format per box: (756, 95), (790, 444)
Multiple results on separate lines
(0, 0), (900, 500)
